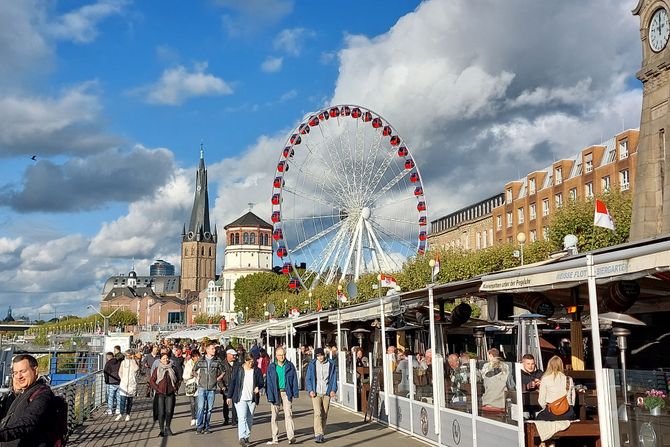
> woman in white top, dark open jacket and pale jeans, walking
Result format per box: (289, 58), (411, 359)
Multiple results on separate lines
(226, 352), (263, 447)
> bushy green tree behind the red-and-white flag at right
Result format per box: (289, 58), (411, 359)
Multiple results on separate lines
(549, 190), (633, 251)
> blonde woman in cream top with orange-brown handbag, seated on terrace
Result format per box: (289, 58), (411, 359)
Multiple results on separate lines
(535, 355), (576, 421)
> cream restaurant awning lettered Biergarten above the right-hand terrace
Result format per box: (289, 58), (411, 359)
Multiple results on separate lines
(480, 238), (670, 292)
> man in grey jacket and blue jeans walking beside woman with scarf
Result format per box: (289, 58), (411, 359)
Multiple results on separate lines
(195, 341), (223, 434)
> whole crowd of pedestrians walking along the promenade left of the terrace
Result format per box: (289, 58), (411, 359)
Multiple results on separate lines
(104, 340), (337, 446)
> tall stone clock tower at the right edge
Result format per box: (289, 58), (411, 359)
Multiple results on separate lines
(630, 0), (670, 240)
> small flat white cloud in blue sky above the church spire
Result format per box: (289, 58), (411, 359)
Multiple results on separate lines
(140, 62), (233, 105)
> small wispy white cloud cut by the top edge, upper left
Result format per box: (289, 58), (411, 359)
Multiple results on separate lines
(48, 0), (128, 43)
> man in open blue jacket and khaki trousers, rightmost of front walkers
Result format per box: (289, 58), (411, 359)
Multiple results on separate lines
(305, 348), (337, 443)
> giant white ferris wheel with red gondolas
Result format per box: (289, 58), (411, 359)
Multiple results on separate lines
(271, 105), (428, 288)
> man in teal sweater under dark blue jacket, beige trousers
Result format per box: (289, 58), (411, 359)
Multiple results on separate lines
(265, 347), (298, 445)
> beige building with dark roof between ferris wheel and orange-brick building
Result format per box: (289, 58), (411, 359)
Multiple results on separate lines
(428, 194), (504, 250)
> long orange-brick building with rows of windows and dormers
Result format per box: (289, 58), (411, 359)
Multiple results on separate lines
(493, 129), (640, 244)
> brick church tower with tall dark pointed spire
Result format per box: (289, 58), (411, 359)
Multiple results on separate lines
(181, 145), (217, 298)
